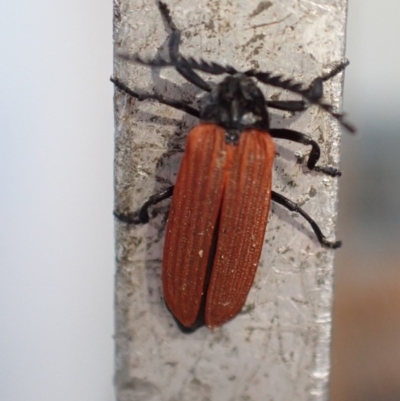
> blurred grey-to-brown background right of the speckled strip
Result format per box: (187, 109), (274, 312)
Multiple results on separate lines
(331, 0), (400, 401)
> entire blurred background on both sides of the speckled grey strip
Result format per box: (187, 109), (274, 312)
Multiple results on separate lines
(0, 0), (400, 401)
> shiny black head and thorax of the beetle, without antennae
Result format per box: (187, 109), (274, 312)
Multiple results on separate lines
(200, 73), (269, 143)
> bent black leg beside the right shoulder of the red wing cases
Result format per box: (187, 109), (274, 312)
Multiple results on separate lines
(269, 128), (342, 177)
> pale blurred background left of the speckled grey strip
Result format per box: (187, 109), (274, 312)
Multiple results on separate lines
(0, 0), (114, 401)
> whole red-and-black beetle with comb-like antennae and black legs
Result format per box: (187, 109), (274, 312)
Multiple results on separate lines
(111, 2), (354, 331)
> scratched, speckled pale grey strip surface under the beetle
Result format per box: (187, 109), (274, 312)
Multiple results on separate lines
(114, 0), (346, 401)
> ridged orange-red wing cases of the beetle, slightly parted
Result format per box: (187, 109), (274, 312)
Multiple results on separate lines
(162, 123), (275, 328)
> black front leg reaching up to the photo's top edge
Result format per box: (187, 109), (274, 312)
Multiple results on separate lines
(157, 1), (211, 92)
